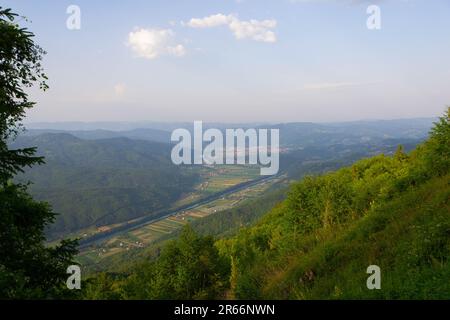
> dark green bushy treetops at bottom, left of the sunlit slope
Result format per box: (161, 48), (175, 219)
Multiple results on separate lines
(84, 226), (229, 299)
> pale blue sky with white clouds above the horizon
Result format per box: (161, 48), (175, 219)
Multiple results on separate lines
(0, 0), (450, 122)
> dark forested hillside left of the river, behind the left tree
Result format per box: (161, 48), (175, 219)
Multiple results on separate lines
(13, 133), (197, 235)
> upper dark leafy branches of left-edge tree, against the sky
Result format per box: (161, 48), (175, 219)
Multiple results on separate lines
(0, 7), (47, 184)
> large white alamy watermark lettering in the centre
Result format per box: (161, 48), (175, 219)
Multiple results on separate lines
(171, 121), (280, 175)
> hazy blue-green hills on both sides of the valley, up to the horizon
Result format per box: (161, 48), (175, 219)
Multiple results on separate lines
(12, 119), (433, 239)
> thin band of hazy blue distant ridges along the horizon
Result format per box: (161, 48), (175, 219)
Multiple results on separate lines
(25, 118), (436, 148)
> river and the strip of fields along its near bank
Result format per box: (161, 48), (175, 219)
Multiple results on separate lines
(77, 169), (287, 270)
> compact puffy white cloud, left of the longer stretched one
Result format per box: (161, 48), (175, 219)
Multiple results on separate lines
(127, 28), (186, 59)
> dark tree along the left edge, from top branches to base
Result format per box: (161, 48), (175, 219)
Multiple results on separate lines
(0, 7), (77, 299)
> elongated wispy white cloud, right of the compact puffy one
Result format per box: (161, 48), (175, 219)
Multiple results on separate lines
(187, 13), (277, 42)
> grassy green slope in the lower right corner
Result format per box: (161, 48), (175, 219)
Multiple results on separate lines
(263, 176), (450, 299)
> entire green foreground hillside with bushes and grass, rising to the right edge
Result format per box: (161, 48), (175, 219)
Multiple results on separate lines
(84, 111), (450, 299)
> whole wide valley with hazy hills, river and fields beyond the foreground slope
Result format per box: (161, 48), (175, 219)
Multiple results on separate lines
(14, 119), (431, 273)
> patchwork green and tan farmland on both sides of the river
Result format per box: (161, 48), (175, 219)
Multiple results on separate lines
(78, 166), (282, 267)
